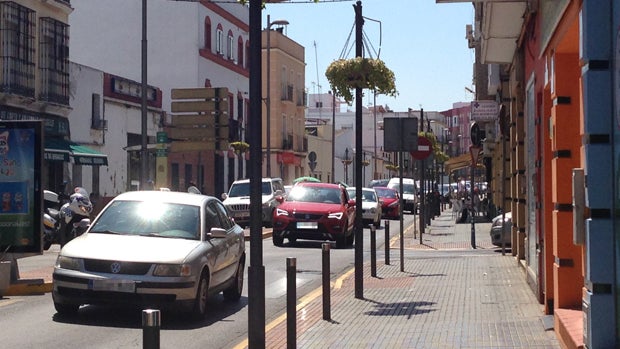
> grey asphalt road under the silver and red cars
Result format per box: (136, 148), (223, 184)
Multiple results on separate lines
(0, 215), (406, 349)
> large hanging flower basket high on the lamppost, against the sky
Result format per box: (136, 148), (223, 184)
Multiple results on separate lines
(325, 57), (398, 103)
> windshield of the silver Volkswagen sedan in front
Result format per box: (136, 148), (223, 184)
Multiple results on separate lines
(90, 201), (200, 240)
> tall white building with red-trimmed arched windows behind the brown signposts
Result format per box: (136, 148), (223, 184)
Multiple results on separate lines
(69, 0), (249, 194)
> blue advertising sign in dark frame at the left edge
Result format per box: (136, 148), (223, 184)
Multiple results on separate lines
(0, 121), (43, 253)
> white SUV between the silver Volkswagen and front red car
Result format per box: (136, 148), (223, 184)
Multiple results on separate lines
(222, 178), (286, 227)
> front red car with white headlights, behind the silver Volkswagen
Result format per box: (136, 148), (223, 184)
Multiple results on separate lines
(273, 182), (355, 248)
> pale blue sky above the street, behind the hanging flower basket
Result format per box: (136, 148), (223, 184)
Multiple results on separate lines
(262, 0), (475, 112)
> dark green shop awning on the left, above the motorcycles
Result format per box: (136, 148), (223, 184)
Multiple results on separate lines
(44, 138), (108, 166)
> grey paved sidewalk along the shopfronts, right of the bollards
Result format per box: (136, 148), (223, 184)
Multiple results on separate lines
(248, 210), (560, 349)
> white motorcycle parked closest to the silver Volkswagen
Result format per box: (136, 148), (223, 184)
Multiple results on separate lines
(58, 187), (93, 247)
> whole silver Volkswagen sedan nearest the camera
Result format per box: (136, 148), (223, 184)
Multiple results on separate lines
(52, 191), (245, 318)
